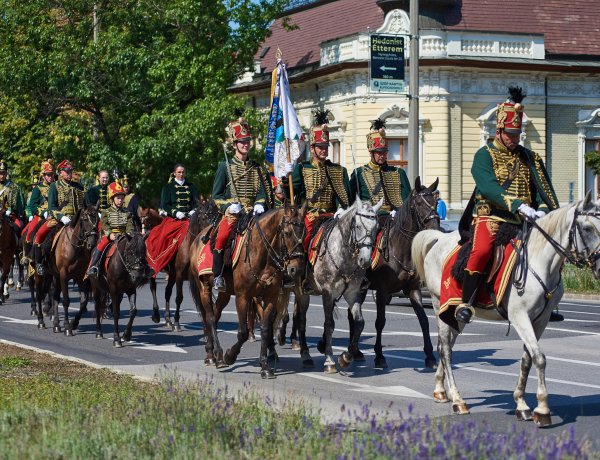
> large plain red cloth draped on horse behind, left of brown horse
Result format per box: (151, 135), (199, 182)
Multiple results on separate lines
(146, 217), (190, 277)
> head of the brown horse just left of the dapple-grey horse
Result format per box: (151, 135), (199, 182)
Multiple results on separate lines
(279, 200), (308, 278)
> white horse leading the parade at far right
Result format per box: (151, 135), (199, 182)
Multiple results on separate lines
(412, 192), (600, 427)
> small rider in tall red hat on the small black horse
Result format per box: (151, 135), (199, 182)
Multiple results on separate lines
(87, 182), (133, 277)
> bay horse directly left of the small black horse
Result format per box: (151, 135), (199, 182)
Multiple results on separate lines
(49, 205), (99, 336)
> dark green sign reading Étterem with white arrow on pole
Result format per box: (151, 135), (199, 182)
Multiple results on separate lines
(370, 34), (405, 93)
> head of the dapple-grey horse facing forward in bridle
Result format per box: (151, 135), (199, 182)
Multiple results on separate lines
(340, 195), (383, 269)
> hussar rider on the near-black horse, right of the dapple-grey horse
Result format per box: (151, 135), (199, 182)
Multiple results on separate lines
(350, 118), (411, 220)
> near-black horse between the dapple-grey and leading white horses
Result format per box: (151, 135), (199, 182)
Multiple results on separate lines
(348, 177), (440, 368)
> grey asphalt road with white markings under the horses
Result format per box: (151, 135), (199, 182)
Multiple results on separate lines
(0, 275), (600, 448)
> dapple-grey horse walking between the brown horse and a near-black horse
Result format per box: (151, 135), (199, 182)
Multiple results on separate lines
(295, 196), (383, 373)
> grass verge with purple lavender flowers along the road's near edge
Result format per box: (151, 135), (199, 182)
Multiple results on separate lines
(0, 344), (594, 459)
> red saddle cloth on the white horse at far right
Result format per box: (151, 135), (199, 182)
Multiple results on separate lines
(439, 240), (521, 329)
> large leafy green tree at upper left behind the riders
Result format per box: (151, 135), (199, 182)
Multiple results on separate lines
(0, 0), (286, 197)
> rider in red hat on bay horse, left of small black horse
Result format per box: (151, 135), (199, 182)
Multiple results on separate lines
(33, 160), (86, 276)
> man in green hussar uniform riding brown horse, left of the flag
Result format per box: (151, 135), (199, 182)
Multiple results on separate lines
(212, 118), (269, 292)
